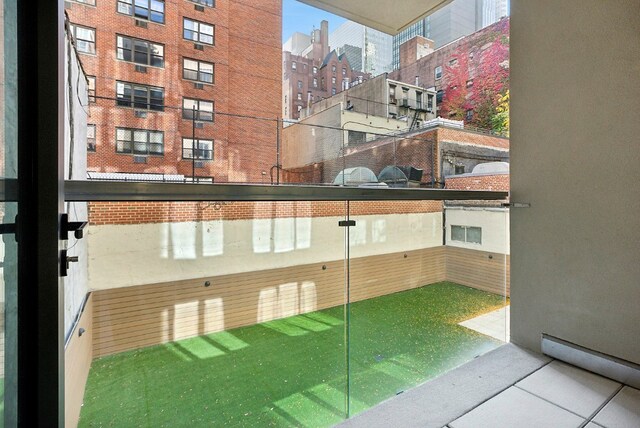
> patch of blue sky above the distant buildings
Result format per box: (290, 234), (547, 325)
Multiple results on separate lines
(282, 0), (346, 43)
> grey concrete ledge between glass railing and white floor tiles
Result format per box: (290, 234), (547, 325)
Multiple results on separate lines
(338, 344), (552, 428)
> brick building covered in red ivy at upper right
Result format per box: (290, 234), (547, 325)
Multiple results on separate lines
(389, 17), (510, 129)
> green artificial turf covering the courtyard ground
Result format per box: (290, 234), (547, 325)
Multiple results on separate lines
(80, 282), (504, 427)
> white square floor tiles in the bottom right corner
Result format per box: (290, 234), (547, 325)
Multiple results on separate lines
(448, 361), (640, 428)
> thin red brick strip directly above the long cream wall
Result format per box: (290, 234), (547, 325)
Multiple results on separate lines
(89, 201), (442, 226)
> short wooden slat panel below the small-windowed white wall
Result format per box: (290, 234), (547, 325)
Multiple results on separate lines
(446, 246), (511, 296)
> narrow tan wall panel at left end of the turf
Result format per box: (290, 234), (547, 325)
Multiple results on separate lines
(64, 295), (93, 427)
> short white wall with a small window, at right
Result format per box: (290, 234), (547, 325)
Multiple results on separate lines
(445, 207), (510, 254)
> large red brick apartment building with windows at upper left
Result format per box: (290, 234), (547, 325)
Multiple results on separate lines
(65, 0), (282, 182)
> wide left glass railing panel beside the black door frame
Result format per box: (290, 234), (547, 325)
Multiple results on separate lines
(66, 201), (347, 427)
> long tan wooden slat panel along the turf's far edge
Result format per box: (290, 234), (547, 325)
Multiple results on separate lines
(93, 247), (445, 357)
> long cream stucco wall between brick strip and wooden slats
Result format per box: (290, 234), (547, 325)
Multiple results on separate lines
(87, 213), (442, 289)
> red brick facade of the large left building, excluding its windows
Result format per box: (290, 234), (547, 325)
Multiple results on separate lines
(67, 0), (282, 182)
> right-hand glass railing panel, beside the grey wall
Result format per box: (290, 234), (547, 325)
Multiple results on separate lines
(349, 201), (508, 415)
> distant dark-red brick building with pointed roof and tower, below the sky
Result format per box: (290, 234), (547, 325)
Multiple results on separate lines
(282, 21), (370, 120)
